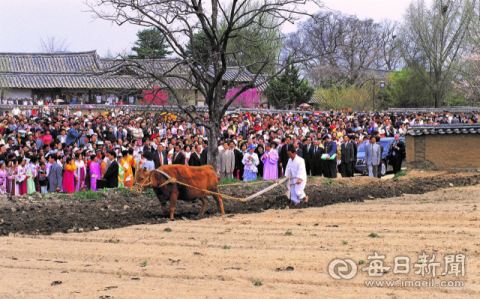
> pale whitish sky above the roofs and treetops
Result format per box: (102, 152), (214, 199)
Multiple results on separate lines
(0, 0), (431, 56)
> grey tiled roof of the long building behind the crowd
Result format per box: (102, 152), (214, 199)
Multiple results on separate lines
(0, 51), (267, 91)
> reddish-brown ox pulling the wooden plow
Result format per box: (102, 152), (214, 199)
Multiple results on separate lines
(135, 165), (225, 219)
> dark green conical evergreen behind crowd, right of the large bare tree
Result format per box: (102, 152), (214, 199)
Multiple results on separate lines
(265, 58), (314, 109)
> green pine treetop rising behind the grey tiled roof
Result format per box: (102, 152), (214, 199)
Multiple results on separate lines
(129, 28), (172, 59)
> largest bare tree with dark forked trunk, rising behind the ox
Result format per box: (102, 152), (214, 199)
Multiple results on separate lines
(88, 0), (334, 170)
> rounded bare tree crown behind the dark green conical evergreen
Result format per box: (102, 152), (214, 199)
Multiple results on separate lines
(286, 12), (393, 87)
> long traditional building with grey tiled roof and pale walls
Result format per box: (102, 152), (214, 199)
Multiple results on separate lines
(0, 51), (266, 105)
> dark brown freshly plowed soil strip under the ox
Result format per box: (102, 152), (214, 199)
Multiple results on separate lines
(0, 173), (480, 235)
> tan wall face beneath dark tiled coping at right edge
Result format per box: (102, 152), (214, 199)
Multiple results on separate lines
(405, 134), (480, 172)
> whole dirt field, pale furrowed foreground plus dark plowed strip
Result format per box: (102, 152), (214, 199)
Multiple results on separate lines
(0, 174), (480, 299)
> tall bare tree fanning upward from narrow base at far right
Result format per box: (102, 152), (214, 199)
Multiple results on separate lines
(399, 0), (476, 108)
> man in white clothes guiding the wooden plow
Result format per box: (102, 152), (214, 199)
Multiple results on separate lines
(285, 146), (308, 205)
